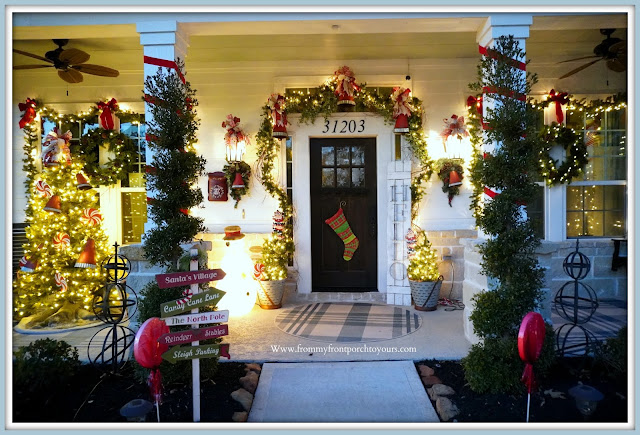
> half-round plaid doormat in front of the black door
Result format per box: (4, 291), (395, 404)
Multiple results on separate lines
(276, 302), (422, 343)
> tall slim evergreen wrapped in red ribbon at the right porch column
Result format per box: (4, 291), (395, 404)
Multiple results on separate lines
(463, 36), (553, 392)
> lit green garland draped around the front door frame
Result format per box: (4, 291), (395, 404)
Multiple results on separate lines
(278, 76), (433, 220)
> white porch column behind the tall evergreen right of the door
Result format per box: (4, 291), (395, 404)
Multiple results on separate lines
(462, 14), (533, 343)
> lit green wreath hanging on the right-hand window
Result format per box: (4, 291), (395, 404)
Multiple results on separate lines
(539, 122), (589, 186)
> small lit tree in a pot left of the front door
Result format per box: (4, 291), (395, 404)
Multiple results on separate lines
(254, 234), (289, 310)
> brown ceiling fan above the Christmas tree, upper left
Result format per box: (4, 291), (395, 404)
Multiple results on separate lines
(13, 39), (120, 83)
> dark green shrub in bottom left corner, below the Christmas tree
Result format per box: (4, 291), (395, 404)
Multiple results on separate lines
(13, 338), (81, 393)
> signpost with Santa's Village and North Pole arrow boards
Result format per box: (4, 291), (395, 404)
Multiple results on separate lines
(156, 247), (231, 422)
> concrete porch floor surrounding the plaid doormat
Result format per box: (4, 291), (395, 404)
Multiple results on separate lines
(12, 298), (471, 363)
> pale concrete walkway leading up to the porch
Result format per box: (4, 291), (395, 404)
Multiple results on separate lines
(248, 361), (440, 423)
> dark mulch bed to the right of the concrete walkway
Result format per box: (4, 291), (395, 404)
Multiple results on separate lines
(418, 358), (627, 423)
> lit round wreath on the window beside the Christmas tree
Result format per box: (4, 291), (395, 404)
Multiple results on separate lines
(70, 128), (138, 186)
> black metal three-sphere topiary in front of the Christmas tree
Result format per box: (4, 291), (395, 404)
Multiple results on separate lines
(87, 243), (138, 374)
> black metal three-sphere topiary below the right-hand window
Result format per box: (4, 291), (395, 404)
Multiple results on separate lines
(553, 240), (599, 356)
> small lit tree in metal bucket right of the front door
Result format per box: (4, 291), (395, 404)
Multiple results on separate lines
(407, 229), (443, 311)
